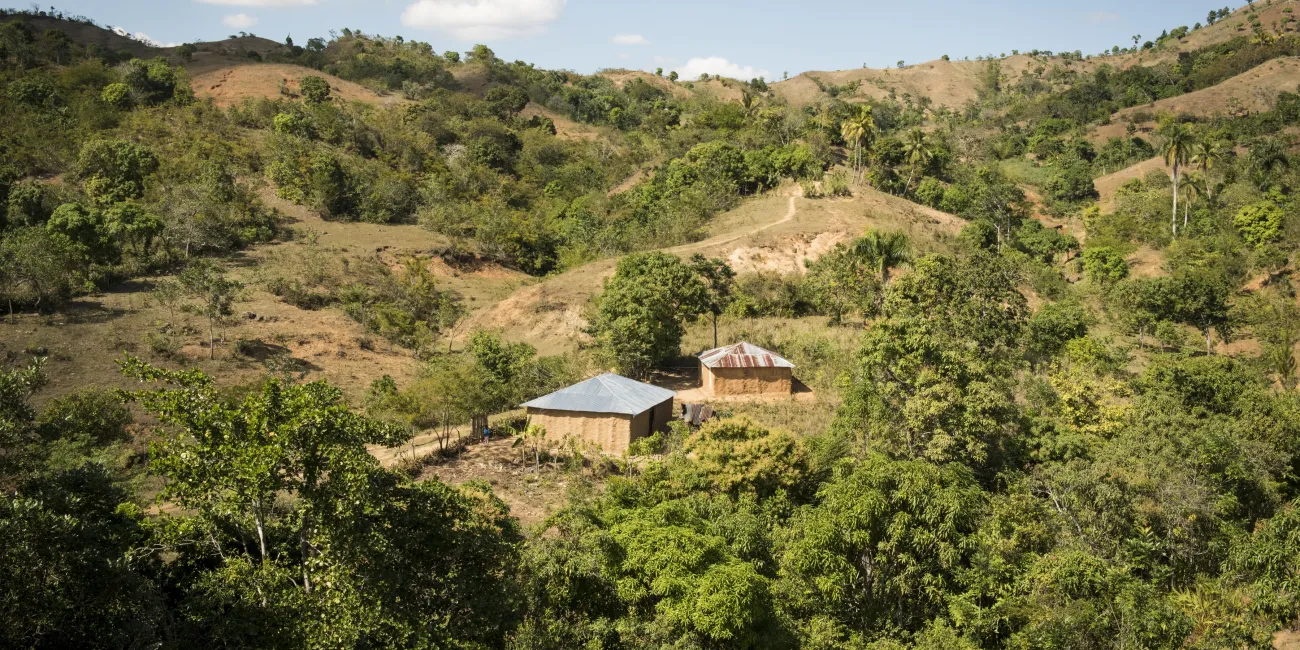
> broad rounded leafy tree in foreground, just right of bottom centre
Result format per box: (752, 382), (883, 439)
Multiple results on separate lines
(774, 455), (985, 634)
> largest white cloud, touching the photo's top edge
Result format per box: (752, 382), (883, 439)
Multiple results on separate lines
(402, 0), (566, 40)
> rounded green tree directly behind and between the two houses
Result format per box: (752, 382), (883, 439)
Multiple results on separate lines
(589, 252), (709, 377)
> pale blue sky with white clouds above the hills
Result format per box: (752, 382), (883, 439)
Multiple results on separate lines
(25, 0), (1242, 79)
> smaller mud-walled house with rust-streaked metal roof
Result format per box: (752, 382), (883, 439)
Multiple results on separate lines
(699, 342), (794, 397)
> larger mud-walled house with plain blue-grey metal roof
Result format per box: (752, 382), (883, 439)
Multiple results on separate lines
(521, 373), (675, 454)
